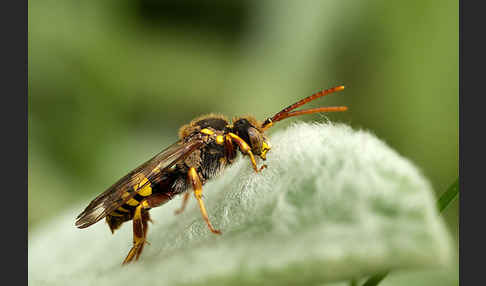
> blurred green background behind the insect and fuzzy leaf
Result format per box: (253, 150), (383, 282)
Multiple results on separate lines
(28, 0), (459, 284)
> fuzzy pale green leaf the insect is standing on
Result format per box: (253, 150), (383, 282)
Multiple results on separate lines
(29, 123), (451, 285)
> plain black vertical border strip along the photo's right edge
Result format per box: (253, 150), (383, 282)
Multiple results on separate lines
(459, 1), (486, 285)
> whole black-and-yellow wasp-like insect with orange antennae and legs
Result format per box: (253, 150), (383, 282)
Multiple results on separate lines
(75, 86), (347, 264)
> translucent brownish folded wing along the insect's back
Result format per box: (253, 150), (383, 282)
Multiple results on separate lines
(75, 139), (204, 228)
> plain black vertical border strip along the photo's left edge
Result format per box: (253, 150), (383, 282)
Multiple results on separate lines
(0, 0), (28, 285)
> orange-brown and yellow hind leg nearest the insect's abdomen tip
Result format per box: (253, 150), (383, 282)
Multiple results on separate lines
(122, 194), (171, 264)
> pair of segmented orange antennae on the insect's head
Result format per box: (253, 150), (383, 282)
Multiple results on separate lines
(262, 85), (348, 130)
